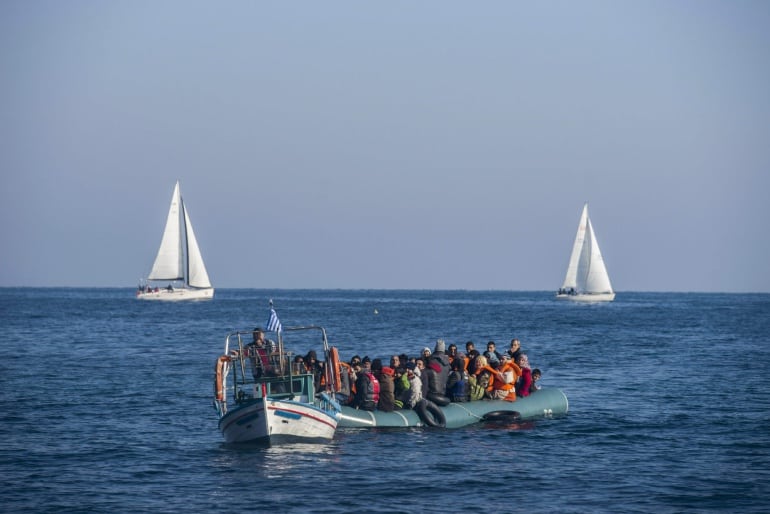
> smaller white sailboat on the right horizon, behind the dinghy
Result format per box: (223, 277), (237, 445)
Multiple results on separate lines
(556, 202), (615, 302)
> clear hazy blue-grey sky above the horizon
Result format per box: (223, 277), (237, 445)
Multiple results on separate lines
(0, 0), (770, 292)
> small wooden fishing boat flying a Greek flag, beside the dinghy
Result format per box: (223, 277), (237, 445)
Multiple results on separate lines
(214, 310), (340, 445)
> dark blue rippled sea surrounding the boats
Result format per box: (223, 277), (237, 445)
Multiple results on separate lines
(0, 288), (770, 514)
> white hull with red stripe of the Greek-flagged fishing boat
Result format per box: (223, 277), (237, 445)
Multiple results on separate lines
(219, 398), (338, 444)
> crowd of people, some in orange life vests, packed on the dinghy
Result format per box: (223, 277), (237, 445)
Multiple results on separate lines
(293, 338), (541, 412)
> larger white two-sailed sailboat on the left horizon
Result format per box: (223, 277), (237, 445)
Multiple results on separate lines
(136, 181), (214, 301)
